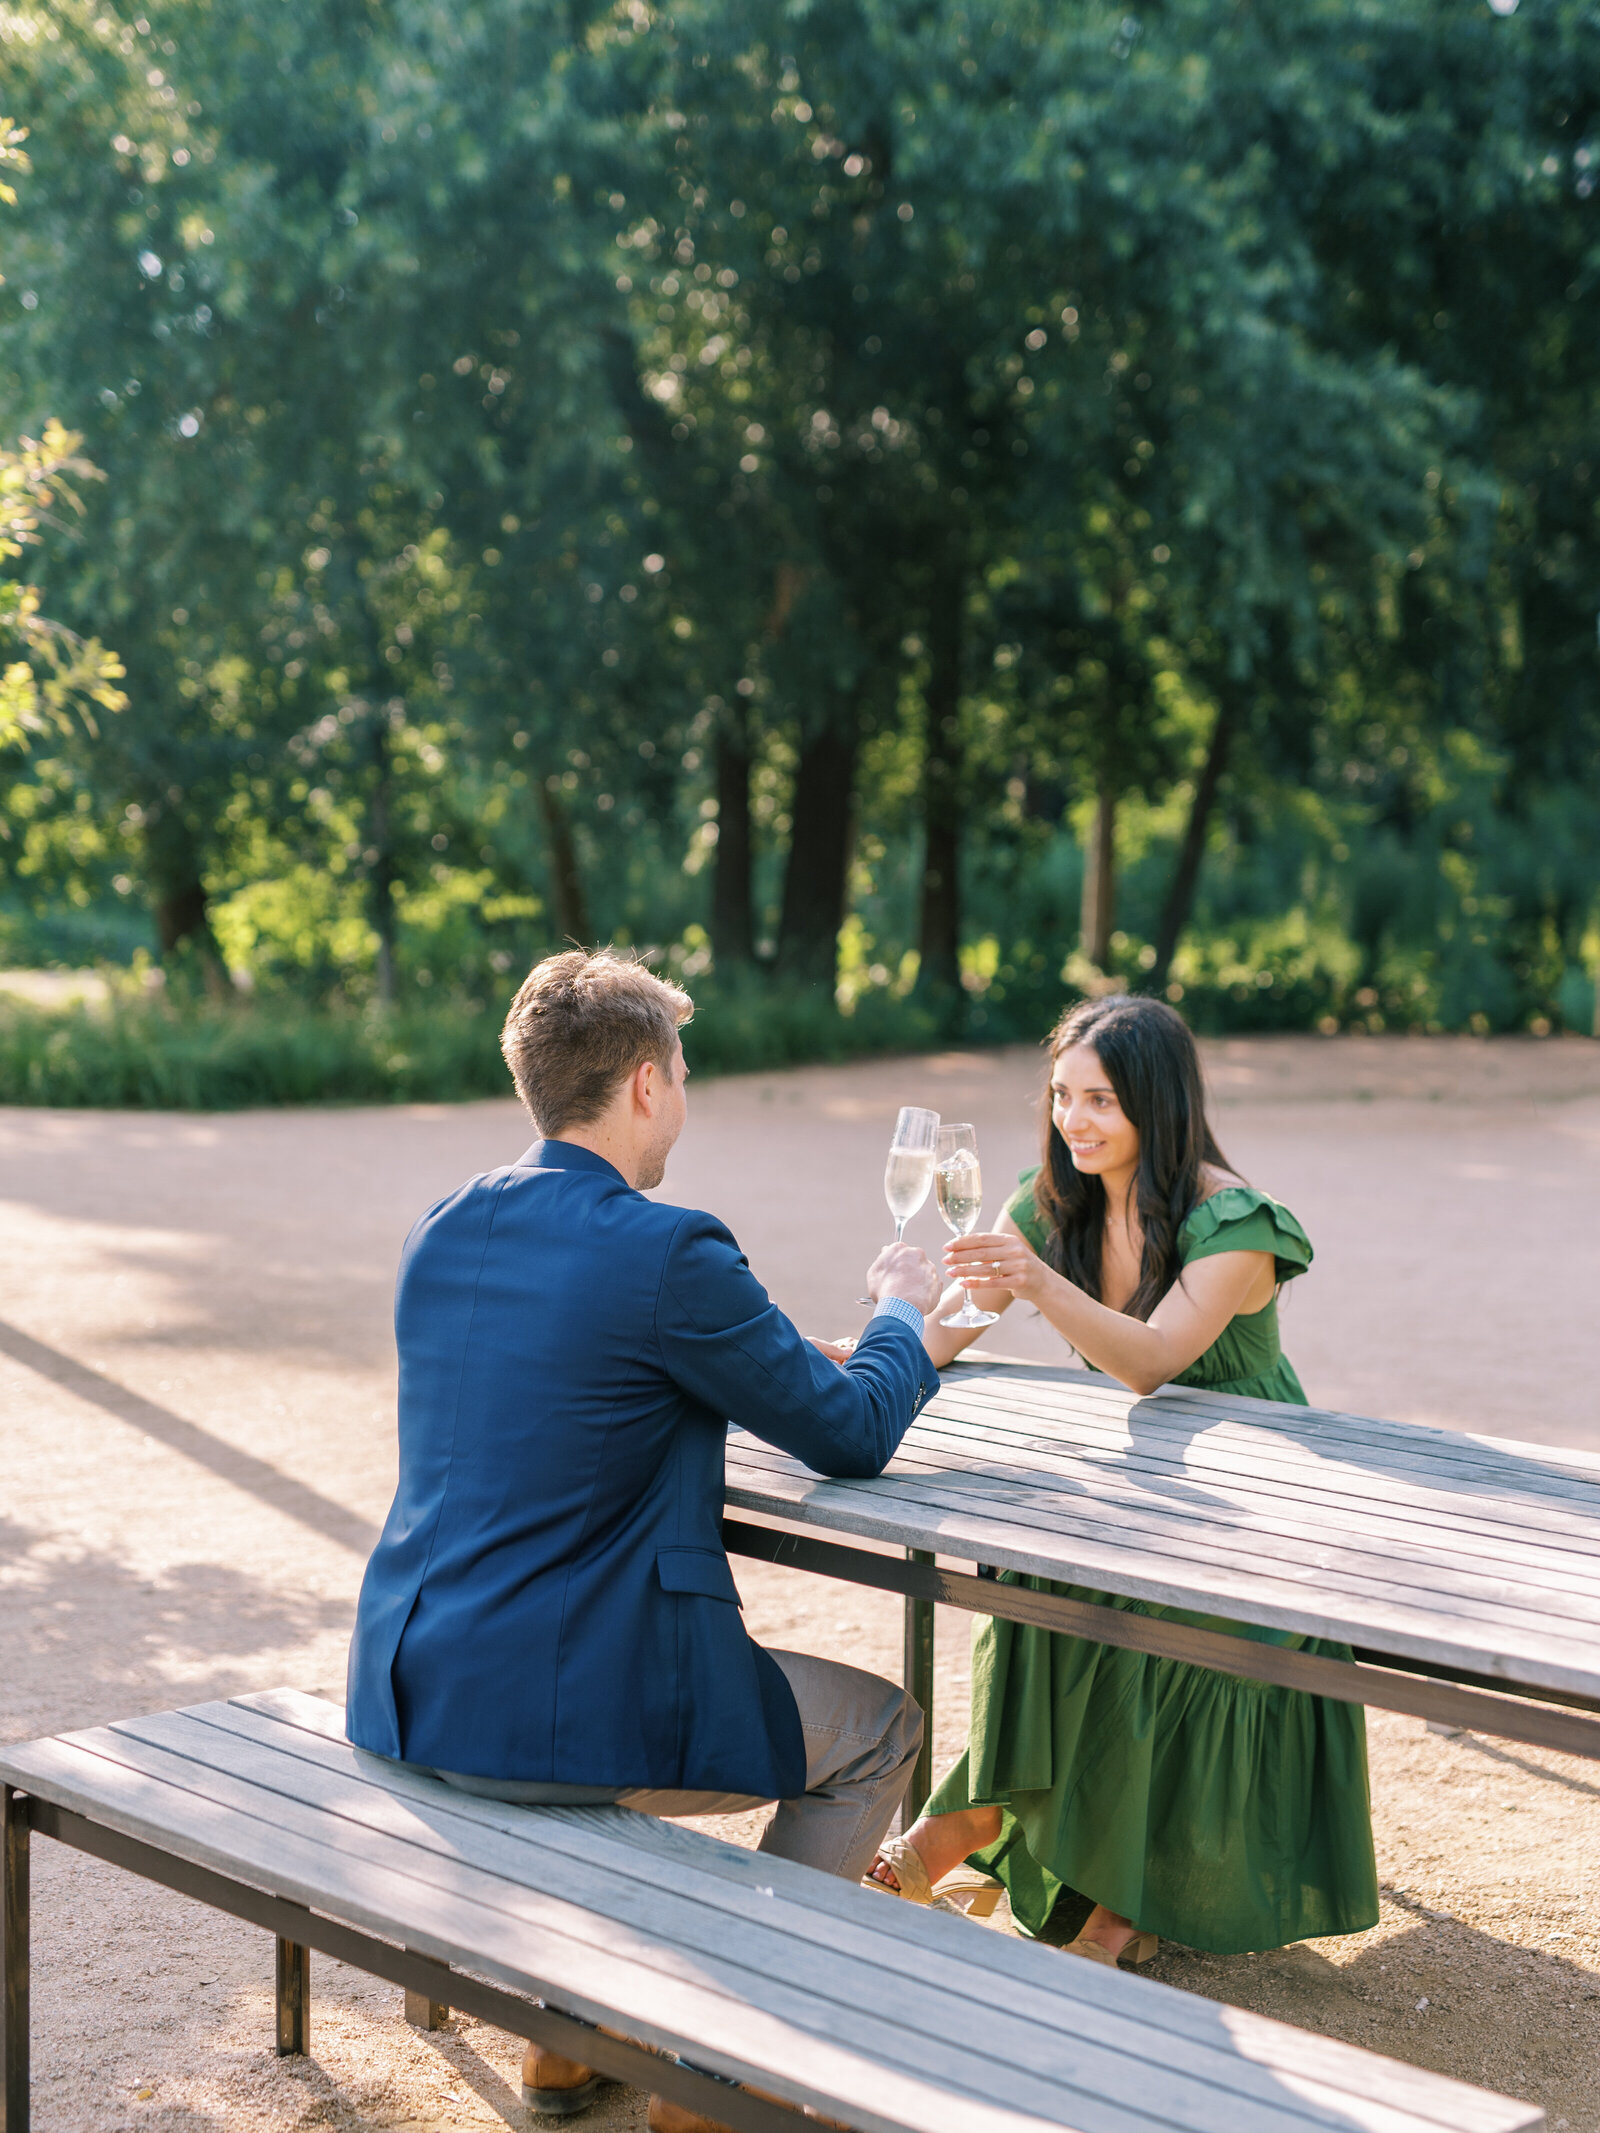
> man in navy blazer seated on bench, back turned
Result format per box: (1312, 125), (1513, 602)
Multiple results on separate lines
(348, 949), (939, 2127)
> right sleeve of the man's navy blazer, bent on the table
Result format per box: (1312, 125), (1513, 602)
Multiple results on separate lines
(655, 1214), (939, 1480)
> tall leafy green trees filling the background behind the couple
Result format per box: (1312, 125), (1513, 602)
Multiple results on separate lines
(0, 0), (1600, 1049)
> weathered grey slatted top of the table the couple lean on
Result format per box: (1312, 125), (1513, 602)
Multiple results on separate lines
(727, 1363), (1600, 1698)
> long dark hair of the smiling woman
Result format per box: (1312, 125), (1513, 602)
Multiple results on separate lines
(1033, 992), (1233, 1318)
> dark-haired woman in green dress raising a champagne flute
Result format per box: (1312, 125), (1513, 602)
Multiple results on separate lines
(873, 998), (1378, 1962)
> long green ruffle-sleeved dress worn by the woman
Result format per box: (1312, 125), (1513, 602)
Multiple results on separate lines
(926, 1171), (1378, 1954)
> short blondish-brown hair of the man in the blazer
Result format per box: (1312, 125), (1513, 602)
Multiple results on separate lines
(499, 947), (693, 1137)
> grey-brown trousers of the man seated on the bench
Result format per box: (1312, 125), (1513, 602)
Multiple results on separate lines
(431, 1651), (922, 1881)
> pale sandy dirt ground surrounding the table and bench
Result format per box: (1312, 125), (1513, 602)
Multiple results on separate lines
(0, 1039), (1600, 2133)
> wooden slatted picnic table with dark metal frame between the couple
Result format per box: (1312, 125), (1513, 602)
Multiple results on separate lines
(725, 1357), (1600, 1805)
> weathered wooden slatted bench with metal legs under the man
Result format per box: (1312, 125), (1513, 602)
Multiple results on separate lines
(0, 1689), (1542, 2133)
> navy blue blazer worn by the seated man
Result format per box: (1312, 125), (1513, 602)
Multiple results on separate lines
(348, 1141), (939, 1798)
